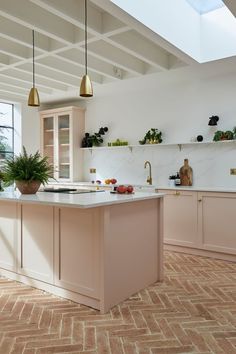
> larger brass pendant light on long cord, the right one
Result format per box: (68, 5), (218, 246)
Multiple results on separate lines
(80, 0), (93, 97)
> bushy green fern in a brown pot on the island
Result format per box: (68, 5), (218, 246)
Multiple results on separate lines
(2, 147), (53, 194)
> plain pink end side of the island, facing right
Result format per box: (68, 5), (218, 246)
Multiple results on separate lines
(102, 199), (163, 312)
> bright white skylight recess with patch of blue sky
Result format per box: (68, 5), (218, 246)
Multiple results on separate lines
(111, 0), (236, 63)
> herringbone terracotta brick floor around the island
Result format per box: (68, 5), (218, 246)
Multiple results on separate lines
(0, 252), (236, 354)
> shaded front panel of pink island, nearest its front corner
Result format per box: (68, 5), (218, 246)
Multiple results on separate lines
(55, 208), (100, 298)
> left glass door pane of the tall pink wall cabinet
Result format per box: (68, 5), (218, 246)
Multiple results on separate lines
(43, 117), (54, 164)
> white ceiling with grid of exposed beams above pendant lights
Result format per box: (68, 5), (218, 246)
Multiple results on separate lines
(0, 0), (234, 102)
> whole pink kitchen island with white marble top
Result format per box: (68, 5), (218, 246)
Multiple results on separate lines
(0, 191), (163, 313)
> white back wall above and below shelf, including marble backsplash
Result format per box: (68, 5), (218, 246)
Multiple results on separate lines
(84, 59), (236, 187)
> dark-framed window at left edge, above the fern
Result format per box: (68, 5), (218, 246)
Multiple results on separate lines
(0, 102), (14, 167)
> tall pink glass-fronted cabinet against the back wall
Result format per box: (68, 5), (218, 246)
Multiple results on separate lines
(40, 107), (84, 181)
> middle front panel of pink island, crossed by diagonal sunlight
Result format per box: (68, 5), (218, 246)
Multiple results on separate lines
(18, 204), (54, 283)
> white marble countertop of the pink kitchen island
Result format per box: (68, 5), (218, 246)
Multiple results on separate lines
(0, 191), (164, 208)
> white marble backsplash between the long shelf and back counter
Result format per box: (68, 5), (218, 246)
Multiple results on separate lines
(84, 141), (236, 188)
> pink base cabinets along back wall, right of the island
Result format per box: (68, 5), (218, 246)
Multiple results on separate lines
(160, 190), (236, 261)
